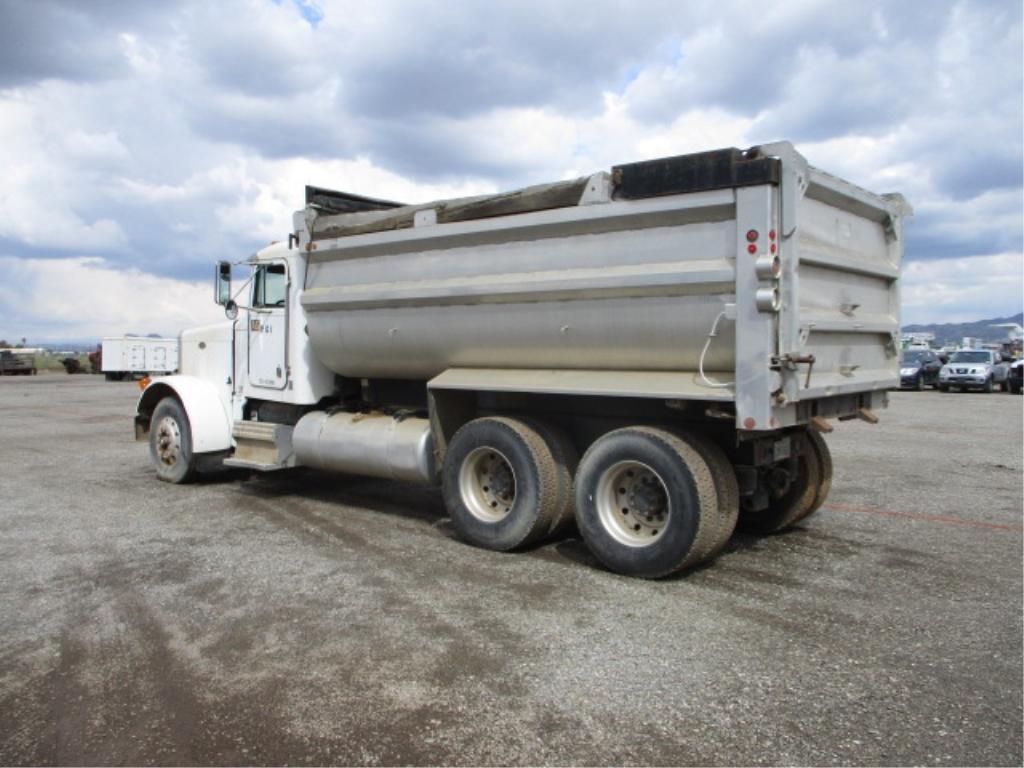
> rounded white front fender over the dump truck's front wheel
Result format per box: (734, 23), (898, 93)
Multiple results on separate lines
(135, 376), (234, 454)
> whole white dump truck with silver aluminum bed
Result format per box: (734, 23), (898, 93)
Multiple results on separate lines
(135, 142), (910, 578)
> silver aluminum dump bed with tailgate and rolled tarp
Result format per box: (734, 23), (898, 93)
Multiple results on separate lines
(296, 142), (909, 431)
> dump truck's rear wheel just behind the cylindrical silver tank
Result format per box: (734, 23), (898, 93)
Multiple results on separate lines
(441, 417), (571, 552)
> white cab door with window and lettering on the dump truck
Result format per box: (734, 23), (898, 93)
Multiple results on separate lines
(248, 261), (289, 389)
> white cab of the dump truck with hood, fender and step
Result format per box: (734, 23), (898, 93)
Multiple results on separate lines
(136, 239), (335, 481)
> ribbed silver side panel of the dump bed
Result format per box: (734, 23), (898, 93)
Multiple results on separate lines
(302, 189), (736, 379)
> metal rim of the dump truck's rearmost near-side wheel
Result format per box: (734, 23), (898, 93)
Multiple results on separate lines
(594, 461), (672, 547)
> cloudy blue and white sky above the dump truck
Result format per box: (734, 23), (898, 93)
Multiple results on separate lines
(0, 0), (1024, 342)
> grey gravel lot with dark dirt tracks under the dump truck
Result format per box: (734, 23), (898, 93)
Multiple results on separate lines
(0, 375), (1024, 765)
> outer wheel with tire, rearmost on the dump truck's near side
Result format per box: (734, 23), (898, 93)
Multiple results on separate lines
(575, 427), (719, 579)
